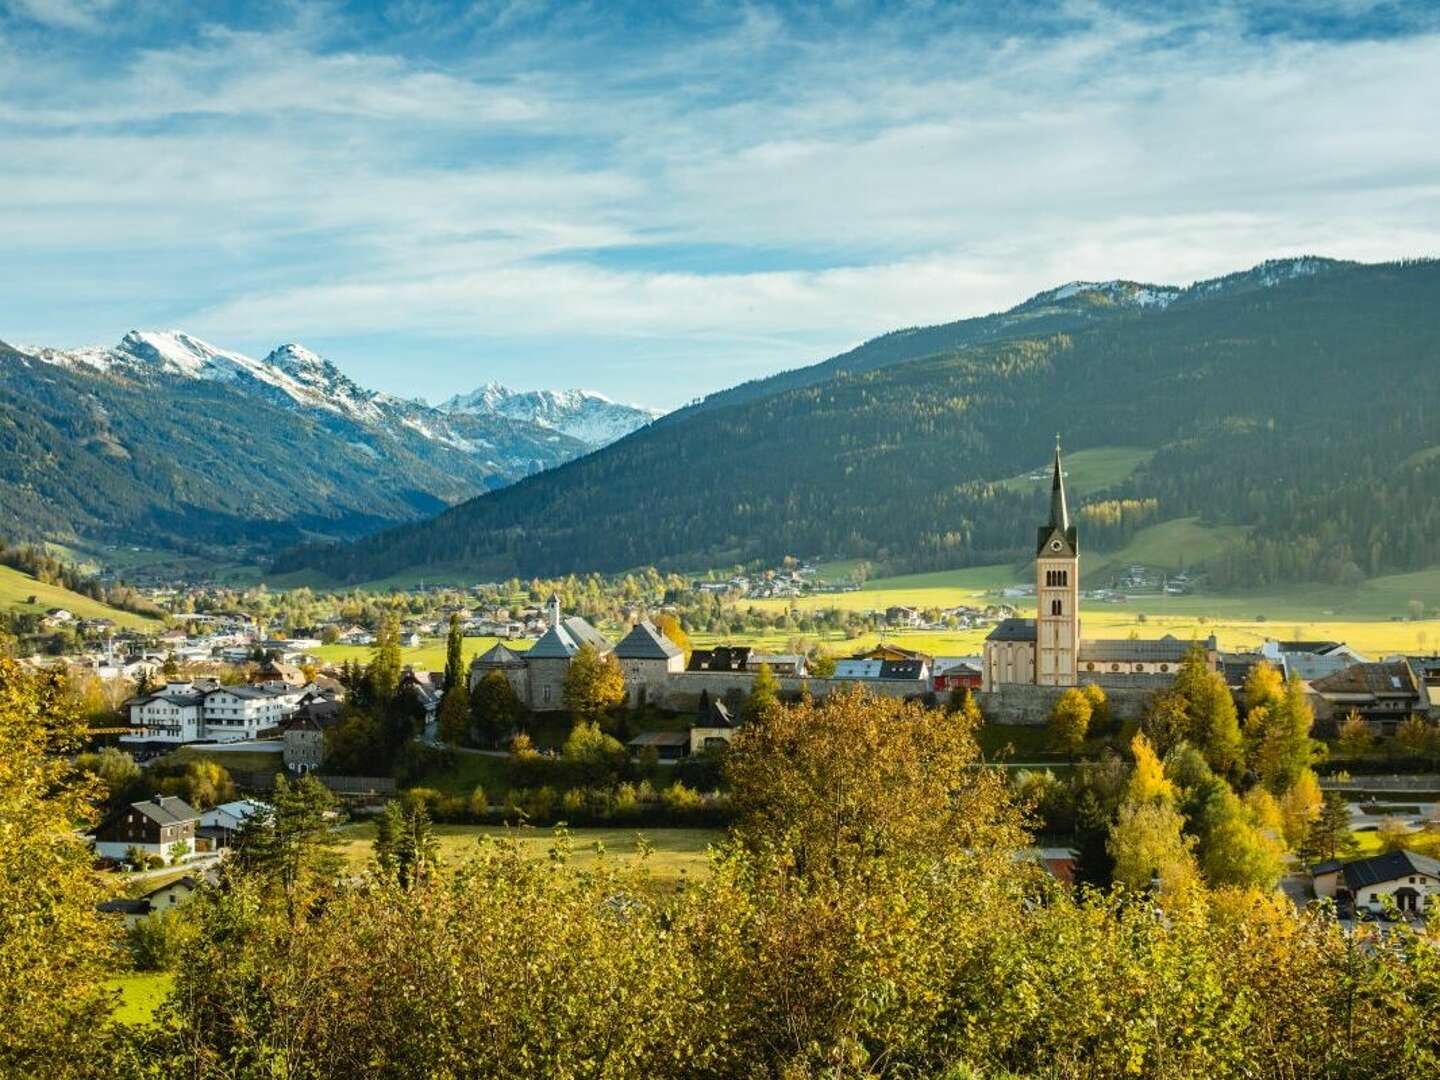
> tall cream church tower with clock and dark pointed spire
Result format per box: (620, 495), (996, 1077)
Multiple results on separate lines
(1035, 435), (1080, 687)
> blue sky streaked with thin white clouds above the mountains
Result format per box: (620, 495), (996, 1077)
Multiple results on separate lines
(0, 0), (1440, 408)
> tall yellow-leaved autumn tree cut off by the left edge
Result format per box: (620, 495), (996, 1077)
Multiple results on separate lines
(0, 657), (118, 1077)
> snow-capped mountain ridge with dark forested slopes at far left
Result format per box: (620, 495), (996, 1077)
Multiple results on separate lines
(0, 330), (613, 562)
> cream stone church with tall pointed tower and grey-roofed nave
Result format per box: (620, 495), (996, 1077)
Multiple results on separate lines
(981, 436), (1218, 691)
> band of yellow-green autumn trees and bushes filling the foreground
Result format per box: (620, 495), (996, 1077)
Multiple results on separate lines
(11, 662), (1440, 1080)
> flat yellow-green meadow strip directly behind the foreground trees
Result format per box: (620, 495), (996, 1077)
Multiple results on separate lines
(337, 822), (724, 884)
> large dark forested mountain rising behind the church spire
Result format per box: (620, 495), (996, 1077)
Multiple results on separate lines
(278, 259), (1440, 585)
